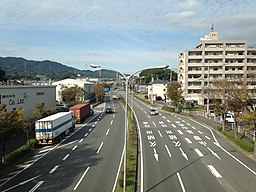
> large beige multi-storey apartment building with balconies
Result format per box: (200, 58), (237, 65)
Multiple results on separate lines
(178, 31), (256, 105)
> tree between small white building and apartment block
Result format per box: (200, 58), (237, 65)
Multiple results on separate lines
(166, 82), (183, 109)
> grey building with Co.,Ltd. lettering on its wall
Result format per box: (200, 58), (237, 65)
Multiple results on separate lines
(0, 85), (56, 116)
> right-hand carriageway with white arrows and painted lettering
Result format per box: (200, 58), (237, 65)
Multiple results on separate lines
(132, 97), (256, 192)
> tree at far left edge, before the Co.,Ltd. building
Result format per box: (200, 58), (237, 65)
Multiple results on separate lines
(0, 109), (24, 163)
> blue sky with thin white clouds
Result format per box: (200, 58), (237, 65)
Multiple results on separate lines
(0, 0), (256, 73)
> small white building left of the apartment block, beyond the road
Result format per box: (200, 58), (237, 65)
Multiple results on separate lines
(148, 79), (169, 101)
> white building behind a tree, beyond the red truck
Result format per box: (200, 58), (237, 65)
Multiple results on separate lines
(52, 78), (94, 102)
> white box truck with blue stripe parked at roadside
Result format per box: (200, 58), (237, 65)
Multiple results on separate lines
(35, 112), (75, 144)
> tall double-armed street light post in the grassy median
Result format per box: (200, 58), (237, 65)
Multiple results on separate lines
(90, 64), (169, 191)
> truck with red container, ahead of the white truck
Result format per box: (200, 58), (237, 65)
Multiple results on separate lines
(69, 103), (93, 123)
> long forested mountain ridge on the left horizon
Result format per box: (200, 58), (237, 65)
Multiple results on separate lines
(0, 57), (116, 80)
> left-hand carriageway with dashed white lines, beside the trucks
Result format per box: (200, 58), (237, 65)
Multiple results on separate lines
(0, 101), (124, 192)
